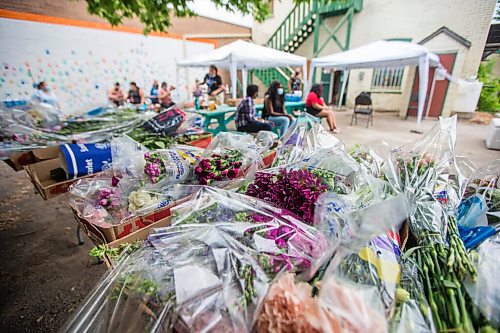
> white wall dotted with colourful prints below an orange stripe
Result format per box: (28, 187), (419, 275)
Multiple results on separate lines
(0, 19), (214, 114)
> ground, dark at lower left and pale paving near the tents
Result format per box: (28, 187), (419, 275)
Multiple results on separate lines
(0, 113), (500, 332)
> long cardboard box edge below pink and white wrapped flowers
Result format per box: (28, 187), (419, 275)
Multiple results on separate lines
(70, 196), (189, 245)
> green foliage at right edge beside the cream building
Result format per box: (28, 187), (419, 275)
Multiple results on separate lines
(477, 60), (500, 113)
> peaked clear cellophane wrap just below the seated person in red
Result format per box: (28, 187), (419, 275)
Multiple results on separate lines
(272, 114), (344, 167)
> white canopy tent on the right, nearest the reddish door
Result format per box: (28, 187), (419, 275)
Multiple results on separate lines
(309, 41), (442, 126)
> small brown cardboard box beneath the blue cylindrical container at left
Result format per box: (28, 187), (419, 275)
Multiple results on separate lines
(25, 158), (99, 200)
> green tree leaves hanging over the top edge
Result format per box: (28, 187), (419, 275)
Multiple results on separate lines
(81, 0), (269, 34)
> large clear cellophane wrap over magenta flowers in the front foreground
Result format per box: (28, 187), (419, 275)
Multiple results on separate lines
(62, 187), (331, 332)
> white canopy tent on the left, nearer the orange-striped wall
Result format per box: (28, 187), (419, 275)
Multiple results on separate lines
(177, 40), (307, 98)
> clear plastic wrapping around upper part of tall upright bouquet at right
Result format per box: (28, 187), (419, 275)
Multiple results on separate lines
(389, 116), (457, 240)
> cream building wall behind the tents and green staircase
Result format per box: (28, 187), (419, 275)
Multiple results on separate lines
(252, 0), (496, 115)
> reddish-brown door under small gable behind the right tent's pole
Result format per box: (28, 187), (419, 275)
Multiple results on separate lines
(407, 53), (457, 117)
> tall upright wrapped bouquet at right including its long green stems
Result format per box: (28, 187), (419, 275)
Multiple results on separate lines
(390, 116), (488, 331)
